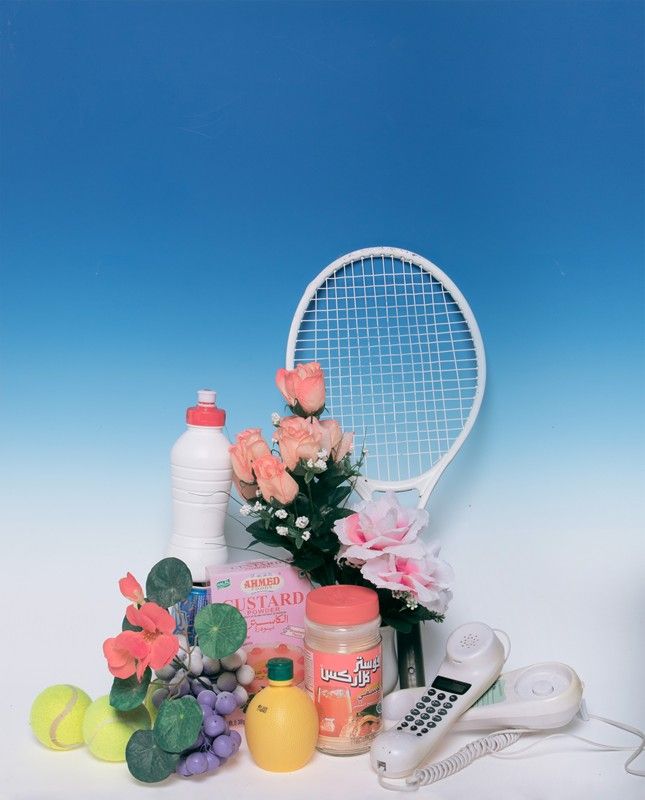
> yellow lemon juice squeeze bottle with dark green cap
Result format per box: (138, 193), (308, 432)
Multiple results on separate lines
(244, 658), (318, 772)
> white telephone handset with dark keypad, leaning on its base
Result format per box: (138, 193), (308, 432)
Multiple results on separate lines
(370, 622), (507, 778)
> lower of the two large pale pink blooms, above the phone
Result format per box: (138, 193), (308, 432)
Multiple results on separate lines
(361, 542), (454, 614)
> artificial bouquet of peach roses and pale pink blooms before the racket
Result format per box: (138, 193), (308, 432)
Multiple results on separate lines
(230, 362), (453, 633)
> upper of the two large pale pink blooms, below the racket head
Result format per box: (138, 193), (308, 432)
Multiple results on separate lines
(334, 492), (428, 566)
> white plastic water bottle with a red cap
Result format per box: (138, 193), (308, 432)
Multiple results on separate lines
(169, 389), (232, 583)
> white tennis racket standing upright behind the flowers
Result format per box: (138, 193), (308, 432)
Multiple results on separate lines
(286, 247), (486, 687)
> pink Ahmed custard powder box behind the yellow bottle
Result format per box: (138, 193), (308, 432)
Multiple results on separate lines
(206, 559), (311, 694)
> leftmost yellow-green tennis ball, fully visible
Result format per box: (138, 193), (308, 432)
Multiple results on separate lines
(29, 683), (92, 750)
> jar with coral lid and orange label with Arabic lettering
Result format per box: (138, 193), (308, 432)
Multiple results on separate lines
(305, 585), (383, 756)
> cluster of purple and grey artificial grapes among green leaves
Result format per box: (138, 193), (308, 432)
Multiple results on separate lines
(152, 636), (255, 777)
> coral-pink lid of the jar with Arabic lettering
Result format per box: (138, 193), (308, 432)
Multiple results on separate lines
(305, 584), (379, 626)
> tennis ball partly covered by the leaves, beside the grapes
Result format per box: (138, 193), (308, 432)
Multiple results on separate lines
(83, 695), (150, 761)
